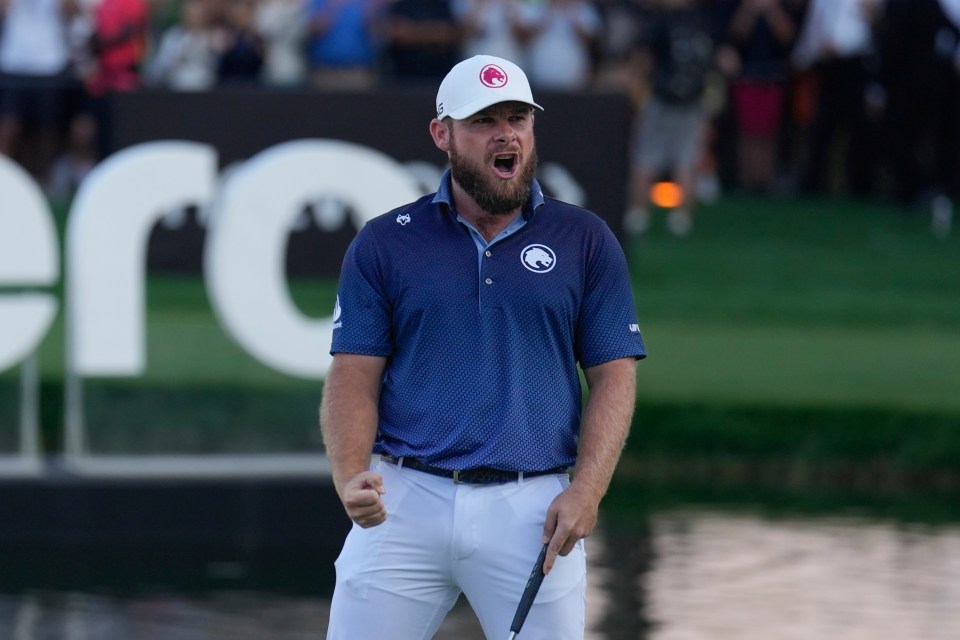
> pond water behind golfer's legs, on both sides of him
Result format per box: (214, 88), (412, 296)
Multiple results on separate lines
(0, 510), (960, 640)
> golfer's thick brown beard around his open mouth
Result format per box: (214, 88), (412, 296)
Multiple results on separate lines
(450, 137), (537, 216)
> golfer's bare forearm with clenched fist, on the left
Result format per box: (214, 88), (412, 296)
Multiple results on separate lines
(320, 353), (387, 527)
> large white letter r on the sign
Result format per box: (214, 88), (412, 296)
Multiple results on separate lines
(66, 141), (217, 376)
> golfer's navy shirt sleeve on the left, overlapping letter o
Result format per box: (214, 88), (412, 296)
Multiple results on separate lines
(330, 226), (393, 357)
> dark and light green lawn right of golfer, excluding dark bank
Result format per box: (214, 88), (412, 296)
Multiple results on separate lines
(628, 198), (960, 417)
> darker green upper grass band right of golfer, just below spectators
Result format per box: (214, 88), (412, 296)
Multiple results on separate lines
(628, 198), (960, 332)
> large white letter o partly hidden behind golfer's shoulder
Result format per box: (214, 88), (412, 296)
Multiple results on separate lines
(204, 140), (422, 378)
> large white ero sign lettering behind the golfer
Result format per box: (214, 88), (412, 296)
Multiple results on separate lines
(0, 139), (584, 379)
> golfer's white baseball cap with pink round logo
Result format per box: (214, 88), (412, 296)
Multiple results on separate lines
(437, 56), (543, 120)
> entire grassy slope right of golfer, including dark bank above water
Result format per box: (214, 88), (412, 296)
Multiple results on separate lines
(621, 198), (960, 493)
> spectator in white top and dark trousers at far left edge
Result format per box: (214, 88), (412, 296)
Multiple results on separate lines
(0, 0), (75, 182)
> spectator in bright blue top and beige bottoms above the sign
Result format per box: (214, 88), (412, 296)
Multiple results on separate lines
(307, 0), (385, 89)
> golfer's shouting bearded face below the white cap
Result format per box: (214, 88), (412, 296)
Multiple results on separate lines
(447, 102), (537, 215)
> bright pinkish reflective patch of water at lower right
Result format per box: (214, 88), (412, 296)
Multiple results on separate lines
(642, 512), (960, 640)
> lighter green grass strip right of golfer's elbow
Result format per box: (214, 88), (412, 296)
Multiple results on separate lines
(638, 321), (960, 416)
